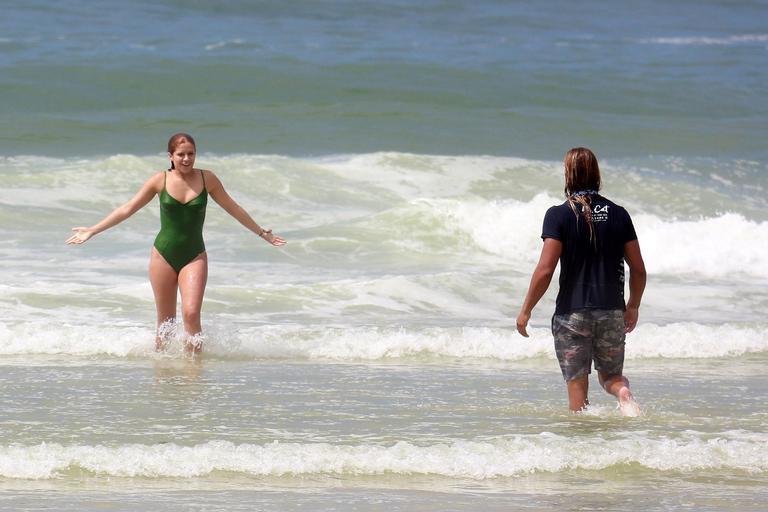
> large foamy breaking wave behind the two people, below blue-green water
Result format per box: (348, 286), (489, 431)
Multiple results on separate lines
(0, 153), (768, 279)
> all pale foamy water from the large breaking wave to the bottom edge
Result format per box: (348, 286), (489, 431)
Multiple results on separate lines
(0, 153), (768, 510)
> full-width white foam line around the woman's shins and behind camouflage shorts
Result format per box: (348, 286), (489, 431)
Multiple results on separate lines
(0, 322), (768, 362)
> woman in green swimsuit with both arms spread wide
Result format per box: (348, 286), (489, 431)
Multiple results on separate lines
(67, 133), (285, 352)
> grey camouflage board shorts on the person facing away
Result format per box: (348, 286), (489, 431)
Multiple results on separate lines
(552, 309), (625, 381)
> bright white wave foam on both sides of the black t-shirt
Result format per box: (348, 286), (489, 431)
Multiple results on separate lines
(429, 194), (768, 279)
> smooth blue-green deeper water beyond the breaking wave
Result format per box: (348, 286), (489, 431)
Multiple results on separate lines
(0, 0), (768, 160)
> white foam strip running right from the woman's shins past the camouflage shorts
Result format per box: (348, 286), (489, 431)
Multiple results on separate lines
(190, 323), (768, 361)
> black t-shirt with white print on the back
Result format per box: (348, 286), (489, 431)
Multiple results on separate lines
(541, 196), (637, 315)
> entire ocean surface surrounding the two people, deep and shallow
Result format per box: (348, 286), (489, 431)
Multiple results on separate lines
(0, 0), (768, 511)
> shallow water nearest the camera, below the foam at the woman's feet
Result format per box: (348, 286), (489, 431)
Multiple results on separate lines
(0, 355), (768, 510)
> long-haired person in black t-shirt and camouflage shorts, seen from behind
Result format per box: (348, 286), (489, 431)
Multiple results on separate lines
(517, 148), (646, 416)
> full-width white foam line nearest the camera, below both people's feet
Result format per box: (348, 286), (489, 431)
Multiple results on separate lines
(0, 432), (768, 480)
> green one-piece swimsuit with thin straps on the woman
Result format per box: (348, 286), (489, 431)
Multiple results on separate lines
(155, 171), (208, 273)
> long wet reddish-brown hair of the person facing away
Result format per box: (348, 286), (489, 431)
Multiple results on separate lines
(563, 147), (600, 242)
